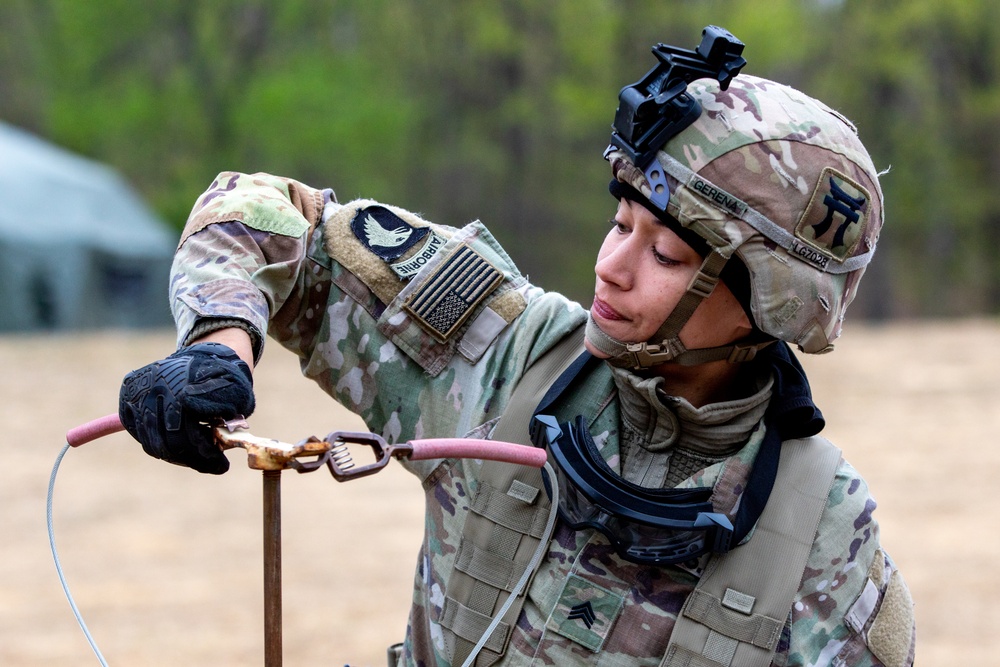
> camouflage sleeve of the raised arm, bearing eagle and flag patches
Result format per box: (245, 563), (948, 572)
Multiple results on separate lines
(127, 172), (586, 474)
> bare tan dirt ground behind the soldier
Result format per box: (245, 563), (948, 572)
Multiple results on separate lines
(0, 321), (1000, 667)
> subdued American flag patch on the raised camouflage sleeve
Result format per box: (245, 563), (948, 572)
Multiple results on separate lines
(403, 245), (503, 343)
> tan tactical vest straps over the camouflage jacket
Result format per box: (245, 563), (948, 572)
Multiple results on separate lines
(430, 328), (841, 667)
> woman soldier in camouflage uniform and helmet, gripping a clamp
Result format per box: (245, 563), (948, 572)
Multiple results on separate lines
(120, 28), (915, 665)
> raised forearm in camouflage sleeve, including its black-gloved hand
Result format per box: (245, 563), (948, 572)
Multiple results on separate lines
(119, 174), (324, 474)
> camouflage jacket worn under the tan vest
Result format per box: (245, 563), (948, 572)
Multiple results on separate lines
(170, 173), (914, 666)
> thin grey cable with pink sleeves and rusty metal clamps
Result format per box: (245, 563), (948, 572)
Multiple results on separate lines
(46, 414), (558, 667)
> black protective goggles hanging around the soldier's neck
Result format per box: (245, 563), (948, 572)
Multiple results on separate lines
(529, 353), (780, 565)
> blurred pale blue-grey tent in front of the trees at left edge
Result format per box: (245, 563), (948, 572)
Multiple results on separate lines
(0, 123), (177, 332)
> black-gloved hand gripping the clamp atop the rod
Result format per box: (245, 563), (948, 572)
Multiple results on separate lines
(118, 343), (254, 475)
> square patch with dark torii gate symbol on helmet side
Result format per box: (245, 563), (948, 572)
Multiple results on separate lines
(791, 167), (871, 268)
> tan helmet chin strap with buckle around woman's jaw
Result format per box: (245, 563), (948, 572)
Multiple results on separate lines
(586, 251), (774, 370)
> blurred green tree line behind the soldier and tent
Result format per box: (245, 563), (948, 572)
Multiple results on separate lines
(0, 0), (1000, 318)
